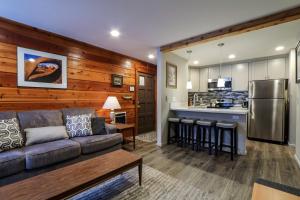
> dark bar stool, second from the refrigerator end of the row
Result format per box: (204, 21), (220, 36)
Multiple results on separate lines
(195, 120), (217, 155)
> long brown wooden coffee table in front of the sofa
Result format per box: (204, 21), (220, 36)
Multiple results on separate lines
(0, 150), (143, 200)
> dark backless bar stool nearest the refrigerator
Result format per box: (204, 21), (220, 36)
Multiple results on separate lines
(216, 122), (238, 160)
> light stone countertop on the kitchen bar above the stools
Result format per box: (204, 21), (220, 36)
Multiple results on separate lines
(170, 106), (248, 115)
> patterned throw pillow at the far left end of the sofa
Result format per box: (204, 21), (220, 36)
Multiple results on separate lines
(0, 118), (23, 152)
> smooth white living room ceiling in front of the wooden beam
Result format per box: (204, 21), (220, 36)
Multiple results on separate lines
(0, 0), (300, 63)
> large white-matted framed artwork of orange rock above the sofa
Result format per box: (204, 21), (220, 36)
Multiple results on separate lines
(17, 47), (67, 89)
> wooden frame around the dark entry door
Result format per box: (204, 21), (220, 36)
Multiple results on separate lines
(134, 70), (157, 135)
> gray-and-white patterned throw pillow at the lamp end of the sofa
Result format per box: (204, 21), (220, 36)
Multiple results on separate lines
(66, 114), (93, 138)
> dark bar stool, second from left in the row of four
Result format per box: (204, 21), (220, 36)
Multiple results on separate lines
(180, 119), (194, 149)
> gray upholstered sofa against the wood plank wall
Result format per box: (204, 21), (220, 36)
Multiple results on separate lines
(0, 108), (123, 186)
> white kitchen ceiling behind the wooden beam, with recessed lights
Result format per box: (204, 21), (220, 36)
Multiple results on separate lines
(174, 20), (300, 66)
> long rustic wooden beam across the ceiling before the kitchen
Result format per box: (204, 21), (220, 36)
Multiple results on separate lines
(160, 6), (300, 52)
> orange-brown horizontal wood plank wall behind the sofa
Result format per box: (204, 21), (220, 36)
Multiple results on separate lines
(0, 18), (156, 122)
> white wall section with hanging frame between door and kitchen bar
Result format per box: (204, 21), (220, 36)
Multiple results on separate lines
(157, 50), (188, 146)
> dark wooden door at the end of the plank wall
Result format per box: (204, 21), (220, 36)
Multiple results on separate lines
(137, 73), (155, 133)
